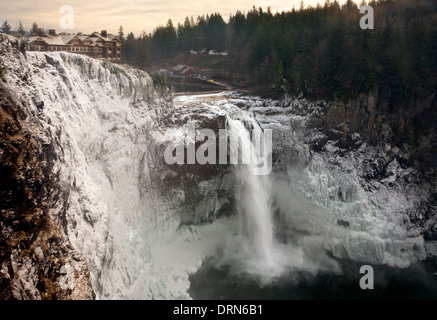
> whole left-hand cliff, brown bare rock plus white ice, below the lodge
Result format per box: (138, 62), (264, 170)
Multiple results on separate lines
(0, 35), (232, 299)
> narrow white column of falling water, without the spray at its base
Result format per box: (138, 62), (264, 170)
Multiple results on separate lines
(228, 118), (274, 265)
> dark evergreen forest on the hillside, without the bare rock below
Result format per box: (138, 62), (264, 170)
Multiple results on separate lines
(124, 0), (437, 106)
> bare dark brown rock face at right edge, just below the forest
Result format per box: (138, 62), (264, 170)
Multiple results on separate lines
(319, 91), (437, 172)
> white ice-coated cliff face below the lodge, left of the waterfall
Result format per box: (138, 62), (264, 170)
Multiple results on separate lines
(0, 35), (232, 299)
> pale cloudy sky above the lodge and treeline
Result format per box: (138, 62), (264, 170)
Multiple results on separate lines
(0, 0), (354, 35)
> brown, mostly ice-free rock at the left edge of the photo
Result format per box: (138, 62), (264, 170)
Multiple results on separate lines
(0, 35), (95, 299)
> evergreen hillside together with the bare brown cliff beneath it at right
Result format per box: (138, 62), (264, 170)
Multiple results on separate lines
(119, 0), (437, 170)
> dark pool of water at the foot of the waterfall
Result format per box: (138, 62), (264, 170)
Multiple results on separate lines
(189, 255), (437, 300)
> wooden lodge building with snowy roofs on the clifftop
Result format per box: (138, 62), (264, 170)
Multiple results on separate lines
(28, 29), (121, 62)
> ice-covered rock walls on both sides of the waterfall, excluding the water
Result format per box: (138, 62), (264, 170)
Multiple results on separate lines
(0, 28), (437, 299)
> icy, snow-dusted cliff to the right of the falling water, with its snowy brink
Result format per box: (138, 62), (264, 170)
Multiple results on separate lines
(175, 93), (437, 277)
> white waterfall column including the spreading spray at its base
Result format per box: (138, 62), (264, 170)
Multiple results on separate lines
(214, 117), (317, 284)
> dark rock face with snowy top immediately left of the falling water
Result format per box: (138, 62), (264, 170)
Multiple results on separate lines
(155, 104), (234, 224)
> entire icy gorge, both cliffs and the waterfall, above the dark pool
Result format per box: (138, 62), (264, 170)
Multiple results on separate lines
(0, 34), (437, 299)
